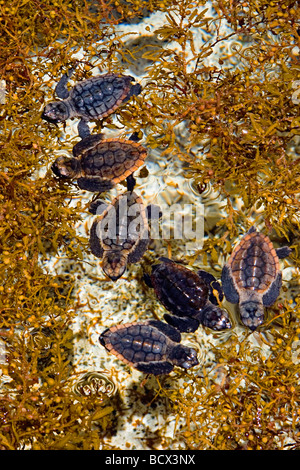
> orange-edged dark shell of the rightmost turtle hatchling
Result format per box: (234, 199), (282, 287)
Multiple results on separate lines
(228, 231), (279, 294)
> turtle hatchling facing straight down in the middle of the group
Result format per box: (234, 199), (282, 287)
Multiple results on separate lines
(90, 191), (161, 281)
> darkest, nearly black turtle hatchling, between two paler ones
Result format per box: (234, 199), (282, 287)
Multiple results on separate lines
(144, 258), (231, 332)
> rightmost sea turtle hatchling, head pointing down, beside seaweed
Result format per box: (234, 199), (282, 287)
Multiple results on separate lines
(221, 227), (292, 331)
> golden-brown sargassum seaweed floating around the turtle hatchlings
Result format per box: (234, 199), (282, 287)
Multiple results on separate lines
(0, 0), (300, 450)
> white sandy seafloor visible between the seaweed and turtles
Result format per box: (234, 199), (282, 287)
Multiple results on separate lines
(39, 4), (298, 450)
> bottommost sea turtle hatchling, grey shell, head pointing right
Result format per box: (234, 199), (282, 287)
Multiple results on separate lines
(99, 320), (198, 375)
